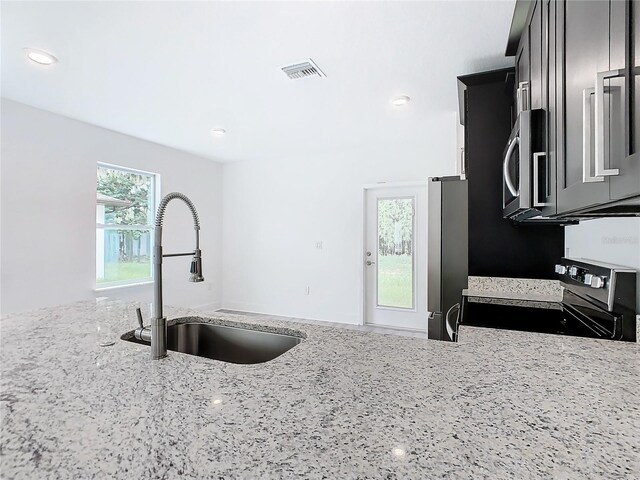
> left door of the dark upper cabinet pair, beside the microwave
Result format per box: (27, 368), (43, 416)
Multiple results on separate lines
(555, 0), (609, 213)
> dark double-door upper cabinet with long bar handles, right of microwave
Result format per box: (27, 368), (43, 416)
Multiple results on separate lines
(554, 0), (640, 214)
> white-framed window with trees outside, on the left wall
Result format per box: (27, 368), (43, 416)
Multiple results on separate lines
(96, 164), (158, 288)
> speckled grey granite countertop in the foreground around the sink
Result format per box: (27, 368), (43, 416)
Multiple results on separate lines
(0, 302), (640, 479)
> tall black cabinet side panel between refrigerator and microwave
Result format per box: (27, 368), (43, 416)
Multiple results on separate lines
(458, 68), (564, 279)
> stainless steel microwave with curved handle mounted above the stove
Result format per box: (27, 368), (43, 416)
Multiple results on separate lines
(502, 109), (548, 221)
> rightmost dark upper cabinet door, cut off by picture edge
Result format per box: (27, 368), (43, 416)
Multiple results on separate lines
(604, 1), (640, 200)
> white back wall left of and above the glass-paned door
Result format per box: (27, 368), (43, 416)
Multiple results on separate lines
(223, 112), (456, 323)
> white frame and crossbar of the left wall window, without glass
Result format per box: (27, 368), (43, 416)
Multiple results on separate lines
(94, 162), (161, 291)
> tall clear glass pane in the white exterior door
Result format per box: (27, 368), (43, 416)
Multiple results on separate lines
(376, 197), (415, 309)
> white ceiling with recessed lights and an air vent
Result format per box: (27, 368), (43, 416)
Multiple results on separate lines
(1, 1), (515, 162)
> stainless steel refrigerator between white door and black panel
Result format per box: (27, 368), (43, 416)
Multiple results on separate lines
(427, 177), (469, 341)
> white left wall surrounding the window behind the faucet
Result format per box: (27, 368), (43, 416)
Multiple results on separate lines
(0, 99), (222, 313)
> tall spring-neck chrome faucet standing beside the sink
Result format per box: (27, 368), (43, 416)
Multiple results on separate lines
(134, 192), (204, 360)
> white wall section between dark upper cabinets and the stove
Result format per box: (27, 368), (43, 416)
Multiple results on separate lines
(565, 218), (640, 311)
